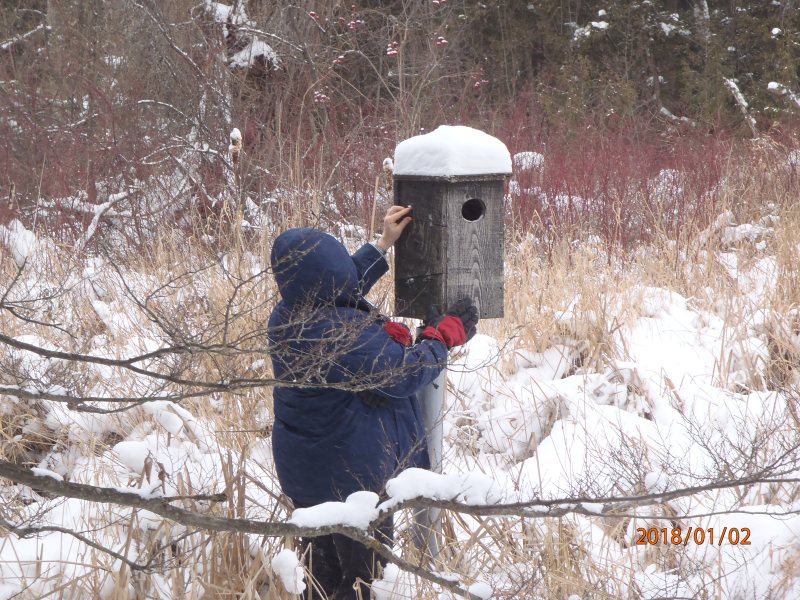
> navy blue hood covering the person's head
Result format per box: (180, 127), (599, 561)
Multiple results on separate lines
(270, 227), (359, 306)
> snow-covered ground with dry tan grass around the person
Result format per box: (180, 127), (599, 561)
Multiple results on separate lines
(0, 189), (800, 600)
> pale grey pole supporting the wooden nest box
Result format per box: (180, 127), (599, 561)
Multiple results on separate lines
(414, 369), (446, 558)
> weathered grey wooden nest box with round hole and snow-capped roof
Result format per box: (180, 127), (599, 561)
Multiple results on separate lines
(394, 126), (511, 319)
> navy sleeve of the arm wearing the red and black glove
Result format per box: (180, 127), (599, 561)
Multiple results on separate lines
(328, 324), (447, 398)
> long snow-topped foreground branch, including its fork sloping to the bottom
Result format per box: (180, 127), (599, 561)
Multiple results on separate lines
(0, 460), (800, 600)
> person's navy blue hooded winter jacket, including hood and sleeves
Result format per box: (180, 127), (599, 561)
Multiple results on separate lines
(269, 228), (447, 506)
